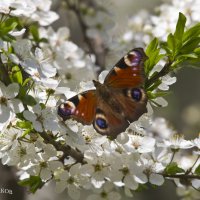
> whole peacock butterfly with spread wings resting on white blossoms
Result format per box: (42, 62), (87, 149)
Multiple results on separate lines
(58, 48), (147, 139)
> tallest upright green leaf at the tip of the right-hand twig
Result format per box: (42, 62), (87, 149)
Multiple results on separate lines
(174, 13), (186, 41)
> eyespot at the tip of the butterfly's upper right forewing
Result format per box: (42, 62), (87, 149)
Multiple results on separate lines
(124, 51), (142, 67)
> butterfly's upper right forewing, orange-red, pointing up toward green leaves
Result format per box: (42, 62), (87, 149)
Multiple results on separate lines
(104, 48), (147, 88)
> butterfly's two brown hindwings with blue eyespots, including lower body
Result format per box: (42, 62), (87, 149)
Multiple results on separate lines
(93, 88), (147, 139)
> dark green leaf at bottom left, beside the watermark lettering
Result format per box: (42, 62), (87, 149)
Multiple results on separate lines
(18, 176), (44, 193)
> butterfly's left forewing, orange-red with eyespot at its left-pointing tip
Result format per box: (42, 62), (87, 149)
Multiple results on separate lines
(58, 90), (97, 125)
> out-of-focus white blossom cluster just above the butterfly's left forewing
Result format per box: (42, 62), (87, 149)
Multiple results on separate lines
(40, 28), (95, 89)
